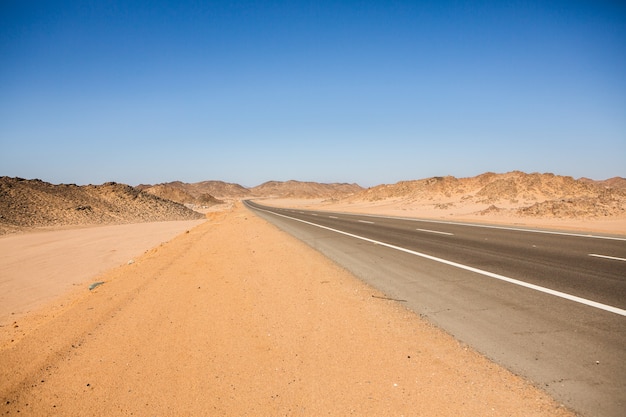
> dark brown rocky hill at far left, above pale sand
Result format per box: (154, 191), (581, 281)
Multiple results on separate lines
(0, 177), (204, 234)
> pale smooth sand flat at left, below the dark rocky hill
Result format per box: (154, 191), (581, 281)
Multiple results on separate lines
(0, 220), (204, 324)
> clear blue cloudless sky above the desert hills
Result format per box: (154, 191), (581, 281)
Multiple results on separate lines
(0, 0), (626, 186)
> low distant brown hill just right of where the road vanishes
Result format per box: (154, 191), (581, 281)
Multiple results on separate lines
(250, 180), (363, 199)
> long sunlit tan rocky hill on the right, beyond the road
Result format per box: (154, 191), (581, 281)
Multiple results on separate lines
(348, 171), (626, 218)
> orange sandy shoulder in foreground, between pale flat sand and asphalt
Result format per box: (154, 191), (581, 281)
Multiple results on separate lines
(0, 205), (572, 416)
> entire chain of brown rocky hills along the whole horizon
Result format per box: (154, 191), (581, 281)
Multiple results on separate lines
(0, 171), (626, 234)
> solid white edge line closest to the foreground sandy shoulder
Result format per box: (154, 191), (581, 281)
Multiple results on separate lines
(257, 209), (626, 317)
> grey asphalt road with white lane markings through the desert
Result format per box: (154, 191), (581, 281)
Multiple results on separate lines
(245, 201), (626, 417)
